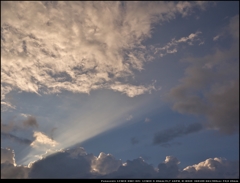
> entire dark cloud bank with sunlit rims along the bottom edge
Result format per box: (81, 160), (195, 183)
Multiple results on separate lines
(1, 148), (239, 178)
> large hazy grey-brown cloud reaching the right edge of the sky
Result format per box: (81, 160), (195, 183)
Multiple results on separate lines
(168, 16), (239, 134)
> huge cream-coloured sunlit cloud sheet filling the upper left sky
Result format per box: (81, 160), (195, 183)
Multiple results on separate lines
(1, 2), (209, 107)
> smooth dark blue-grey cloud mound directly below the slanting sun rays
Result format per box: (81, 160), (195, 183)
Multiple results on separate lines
(29, 149), (93, 178)
